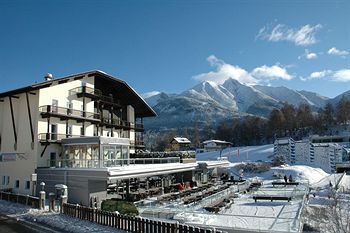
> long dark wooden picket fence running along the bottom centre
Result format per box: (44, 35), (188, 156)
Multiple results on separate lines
(63, 204), (222, 233)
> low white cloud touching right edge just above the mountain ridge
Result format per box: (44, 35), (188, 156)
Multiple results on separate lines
(301, 69), (350, 82)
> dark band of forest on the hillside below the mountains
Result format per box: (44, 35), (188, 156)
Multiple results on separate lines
(145, 98), (350, 151)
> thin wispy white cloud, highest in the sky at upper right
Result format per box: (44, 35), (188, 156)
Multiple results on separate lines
(256, 24), (322, 46)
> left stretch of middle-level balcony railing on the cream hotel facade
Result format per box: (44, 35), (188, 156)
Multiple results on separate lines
(39, 105), (100, 121)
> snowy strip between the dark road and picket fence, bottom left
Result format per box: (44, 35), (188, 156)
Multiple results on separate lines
(0, 200), (124, 233)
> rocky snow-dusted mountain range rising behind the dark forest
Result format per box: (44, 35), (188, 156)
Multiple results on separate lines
(143, 79), (340, 129)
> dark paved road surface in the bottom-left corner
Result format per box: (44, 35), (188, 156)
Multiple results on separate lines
(0, 214), (58, 233)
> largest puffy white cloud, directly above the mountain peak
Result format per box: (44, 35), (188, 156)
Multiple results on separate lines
(193, 55), (293, 85)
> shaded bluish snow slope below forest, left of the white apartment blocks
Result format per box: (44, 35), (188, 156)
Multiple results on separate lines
(196, 144), (273, 163)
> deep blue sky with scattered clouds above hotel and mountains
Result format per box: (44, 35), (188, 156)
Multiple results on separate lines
(0, 0), (350, 97)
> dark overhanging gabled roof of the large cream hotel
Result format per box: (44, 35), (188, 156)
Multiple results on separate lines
(0, 70), (157, 117)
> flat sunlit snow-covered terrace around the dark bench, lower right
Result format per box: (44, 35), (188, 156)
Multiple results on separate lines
(174, 187), (305, 232)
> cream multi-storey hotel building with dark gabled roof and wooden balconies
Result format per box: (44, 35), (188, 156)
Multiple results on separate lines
(0, 71), (155, 194)
